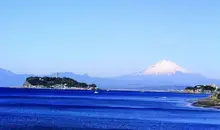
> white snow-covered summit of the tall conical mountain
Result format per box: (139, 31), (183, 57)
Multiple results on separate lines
(136, 60), (188, 75)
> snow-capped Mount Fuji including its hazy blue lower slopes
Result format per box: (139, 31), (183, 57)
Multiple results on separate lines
(117, 60), (220, 89)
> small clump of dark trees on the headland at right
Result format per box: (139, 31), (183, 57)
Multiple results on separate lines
(185, 85), (217, 93)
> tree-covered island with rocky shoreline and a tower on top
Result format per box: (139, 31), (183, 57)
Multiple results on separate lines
(23, 77), (98, 90)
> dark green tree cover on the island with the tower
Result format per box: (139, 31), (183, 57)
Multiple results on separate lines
(26, 77), (97, 89)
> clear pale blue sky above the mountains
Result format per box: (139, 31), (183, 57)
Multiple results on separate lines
(0, 0), (220, 78)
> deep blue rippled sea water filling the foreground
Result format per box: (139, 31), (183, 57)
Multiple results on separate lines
(0, 88), (220, 130)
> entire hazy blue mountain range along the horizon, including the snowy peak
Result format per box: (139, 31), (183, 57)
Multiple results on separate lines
(0, 60), (220, 90)
